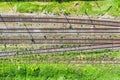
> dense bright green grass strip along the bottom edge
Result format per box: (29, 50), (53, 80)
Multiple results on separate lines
(0, 63), (120, 80)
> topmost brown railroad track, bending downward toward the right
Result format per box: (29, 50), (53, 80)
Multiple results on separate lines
(0, 16), (120, 27)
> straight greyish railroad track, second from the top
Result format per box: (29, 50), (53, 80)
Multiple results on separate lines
(0, 28), (120, 34)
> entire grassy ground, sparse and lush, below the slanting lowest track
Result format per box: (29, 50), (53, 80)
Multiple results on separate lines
(0, 50), (120, 80)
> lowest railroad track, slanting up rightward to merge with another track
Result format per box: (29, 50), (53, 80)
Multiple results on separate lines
(0, 44), (120, 58)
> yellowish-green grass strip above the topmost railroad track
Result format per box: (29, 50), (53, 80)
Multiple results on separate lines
(0, 0), (120, 16)
